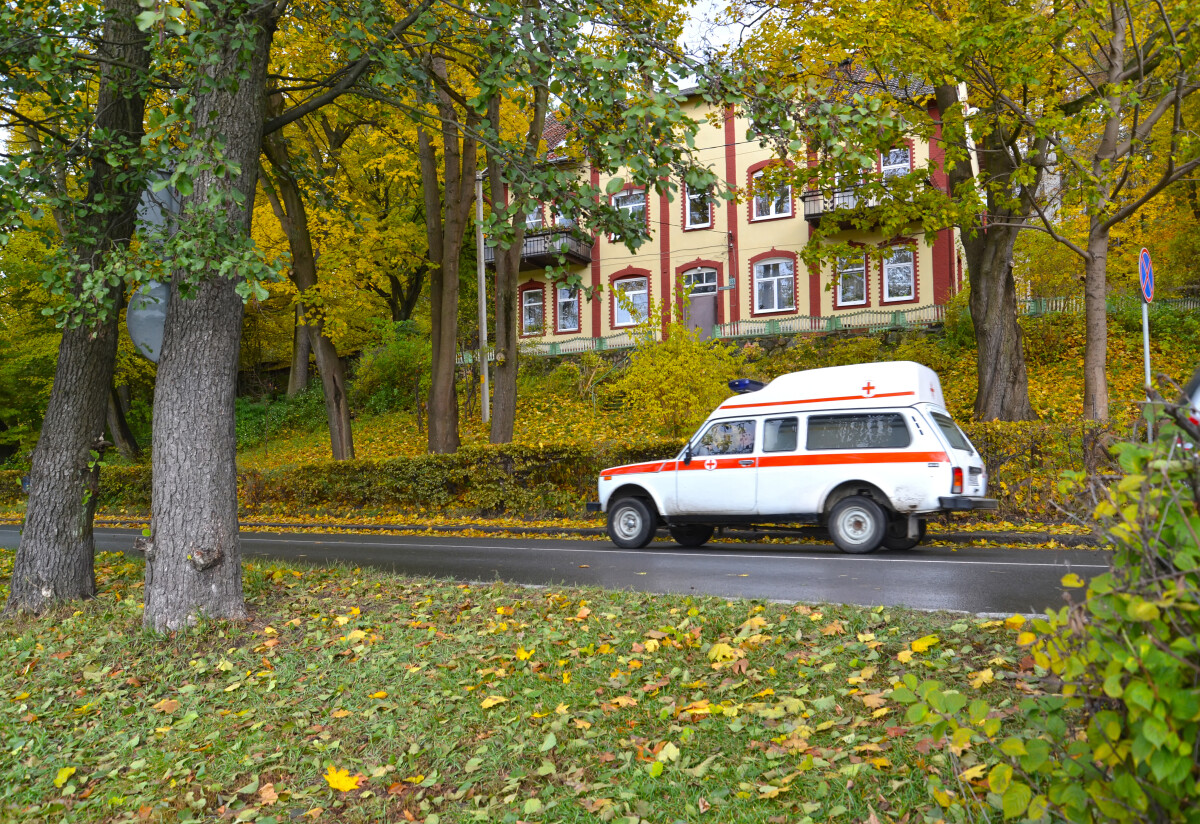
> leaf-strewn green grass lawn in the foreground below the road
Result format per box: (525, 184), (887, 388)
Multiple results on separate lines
(0, 551), (1032, 824)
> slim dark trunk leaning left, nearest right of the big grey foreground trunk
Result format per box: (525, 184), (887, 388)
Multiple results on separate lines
(263, 119), (354, 461)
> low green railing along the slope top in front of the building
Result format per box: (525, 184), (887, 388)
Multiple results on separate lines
(458, 296), (1200, 363)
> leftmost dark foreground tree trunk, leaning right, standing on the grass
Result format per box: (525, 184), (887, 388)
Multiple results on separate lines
(5, 0), (150, 613)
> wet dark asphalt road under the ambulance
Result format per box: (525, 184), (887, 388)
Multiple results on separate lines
(0, 527), (1108, 614)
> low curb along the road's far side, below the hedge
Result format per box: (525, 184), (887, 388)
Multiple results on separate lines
(44, 519), (1100, 549)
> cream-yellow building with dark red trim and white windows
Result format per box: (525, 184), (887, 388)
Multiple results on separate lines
(492, 98), (962, 353)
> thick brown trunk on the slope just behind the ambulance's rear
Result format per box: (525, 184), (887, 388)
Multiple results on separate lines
(935, 85), (1040, 421)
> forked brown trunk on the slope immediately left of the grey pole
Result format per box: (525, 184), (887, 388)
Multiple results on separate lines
(418, 55), (478, 453)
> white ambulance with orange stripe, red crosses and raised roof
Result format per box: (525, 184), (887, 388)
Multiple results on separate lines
(589, 361), (996, 553)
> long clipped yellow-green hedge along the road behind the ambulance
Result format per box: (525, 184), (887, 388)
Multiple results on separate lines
(0, 421), (1115, 519)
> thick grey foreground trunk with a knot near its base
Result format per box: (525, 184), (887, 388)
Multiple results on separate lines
(144, 2), (276, 631)
